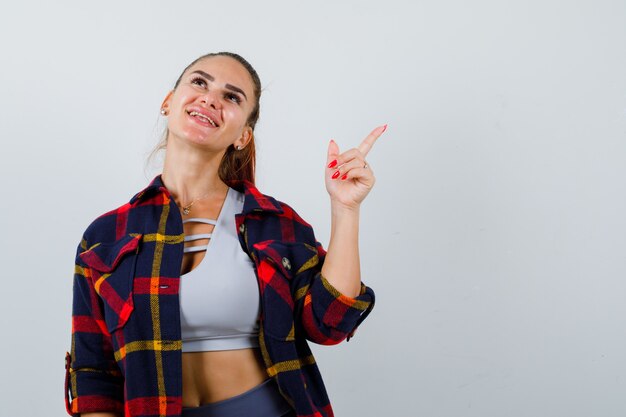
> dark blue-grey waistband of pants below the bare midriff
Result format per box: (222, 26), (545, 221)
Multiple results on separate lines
(182, 378), (295, 417)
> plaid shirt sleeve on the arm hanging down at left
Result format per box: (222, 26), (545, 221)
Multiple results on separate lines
(65, 238), (124, 416)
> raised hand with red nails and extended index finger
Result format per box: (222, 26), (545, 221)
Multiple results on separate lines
(325, 125), (387, 208)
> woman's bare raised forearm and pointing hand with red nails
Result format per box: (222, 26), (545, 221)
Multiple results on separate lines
(322, 125), (387, 297)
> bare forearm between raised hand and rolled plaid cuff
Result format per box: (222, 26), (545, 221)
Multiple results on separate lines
(322, 202), (361, 297)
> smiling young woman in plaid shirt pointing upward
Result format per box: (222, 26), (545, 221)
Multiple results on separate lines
(66, 52), (386, 417)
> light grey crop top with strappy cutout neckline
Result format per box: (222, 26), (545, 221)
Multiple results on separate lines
(180, 188), (260, 352)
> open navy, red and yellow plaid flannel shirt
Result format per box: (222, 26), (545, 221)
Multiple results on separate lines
(65, 175), (374, 417)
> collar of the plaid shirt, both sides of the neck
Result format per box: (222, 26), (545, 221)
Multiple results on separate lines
(129, 174), (283, 214)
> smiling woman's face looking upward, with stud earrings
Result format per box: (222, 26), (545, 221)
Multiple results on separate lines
(162, 56), (256, 151)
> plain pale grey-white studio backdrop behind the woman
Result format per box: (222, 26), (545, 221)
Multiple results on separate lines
(0, 0), (626, 417)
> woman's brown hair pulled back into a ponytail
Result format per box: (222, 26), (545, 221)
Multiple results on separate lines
(148, 52), (261, 183)
